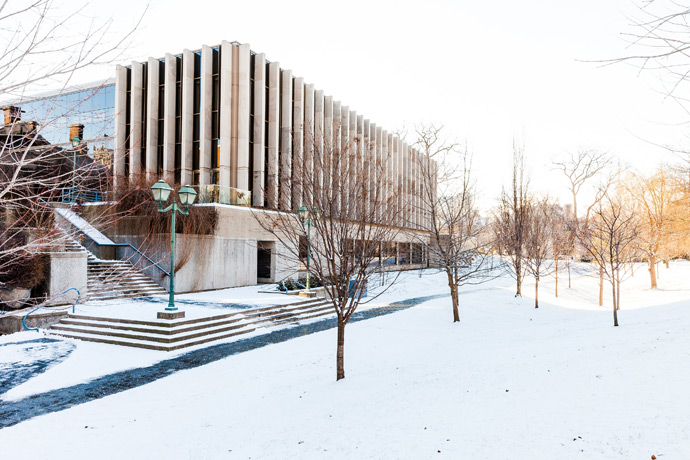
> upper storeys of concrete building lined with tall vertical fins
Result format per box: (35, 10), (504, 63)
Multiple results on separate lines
(113, 42), (430, 220)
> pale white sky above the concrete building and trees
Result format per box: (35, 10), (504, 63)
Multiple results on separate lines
(57, 0), (685, 209)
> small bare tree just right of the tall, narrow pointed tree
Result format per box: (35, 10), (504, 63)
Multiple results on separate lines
(525, 197), (554, 308)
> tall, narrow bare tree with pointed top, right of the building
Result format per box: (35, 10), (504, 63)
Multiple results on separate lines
(494, 142), (530, 297)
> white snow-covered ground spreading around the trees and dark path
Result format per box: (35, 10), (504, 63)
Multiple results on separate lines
(0, 262), (690, 460)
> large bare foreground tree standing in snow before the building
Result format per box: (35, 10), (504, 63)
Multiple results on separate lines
(255, 123), (408, 380)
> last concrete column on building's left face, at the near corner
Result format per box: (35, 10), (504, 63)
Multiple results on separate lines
(218, 41), (233, 193)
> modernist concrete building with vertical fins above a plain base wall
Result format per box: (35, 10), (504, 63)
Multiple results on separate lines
(105, 41), (426, 291)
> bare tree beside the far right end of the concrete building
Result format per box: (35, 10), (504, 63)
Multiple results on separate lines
(415, 125), (496, 322)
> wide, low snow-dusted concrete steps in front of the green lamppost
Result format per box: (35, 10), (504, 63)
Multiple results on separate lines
(48, 299), (333, 351)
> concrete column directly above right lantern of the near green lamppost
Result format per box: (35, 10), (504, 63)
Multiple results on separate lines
(180, 50), (194, 185)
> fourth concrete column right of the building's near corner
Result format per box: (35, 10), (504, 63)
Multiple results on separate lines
(279, 70), (292, 211)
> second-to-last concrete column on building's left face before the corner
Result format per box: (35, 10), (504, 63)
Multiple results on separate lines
(199, 45), (211, 185)
